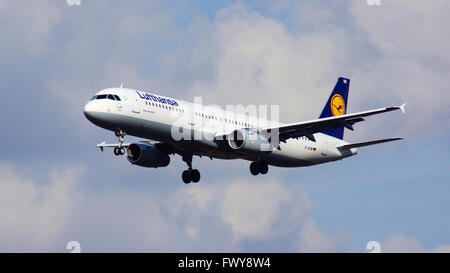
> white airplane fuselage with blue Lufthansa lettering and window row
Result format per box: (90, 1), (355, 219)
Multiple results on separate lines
(84, 88), (356, 167)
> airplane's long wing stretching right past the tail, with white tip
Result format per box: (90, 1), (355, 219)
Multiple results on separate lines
(262, 103), (406, 141)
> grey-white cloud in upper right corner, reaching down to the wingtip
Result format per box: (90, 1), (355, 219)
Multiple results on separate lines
(350, 0), (450, 135)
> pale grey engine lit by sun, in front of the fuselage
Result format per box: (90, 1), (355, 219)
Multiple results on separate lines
(227, 129), (273, 153)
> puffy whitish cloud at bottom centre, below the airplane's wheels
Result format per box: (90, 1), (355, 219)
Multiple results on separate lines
(169, 176), (347, 252)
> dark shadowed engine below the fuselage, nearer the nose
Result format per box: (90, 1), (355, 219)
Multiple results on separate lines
(127, 143), (170, 168)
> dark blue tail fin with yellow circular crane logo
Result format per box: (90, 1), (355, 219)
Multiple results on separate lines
(320, 77), (350, 139)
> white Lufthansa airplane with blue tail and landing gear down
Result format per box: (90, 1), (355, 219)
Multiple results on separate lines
(84, 77), (406, 184)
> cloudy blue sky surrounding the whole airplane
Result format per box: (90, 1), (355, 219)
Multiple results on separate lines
(0, 0), (450, 252)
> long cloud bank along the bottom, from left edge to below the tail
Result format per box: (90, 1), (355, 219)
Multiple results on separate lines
(0, 160), (341, 252)
